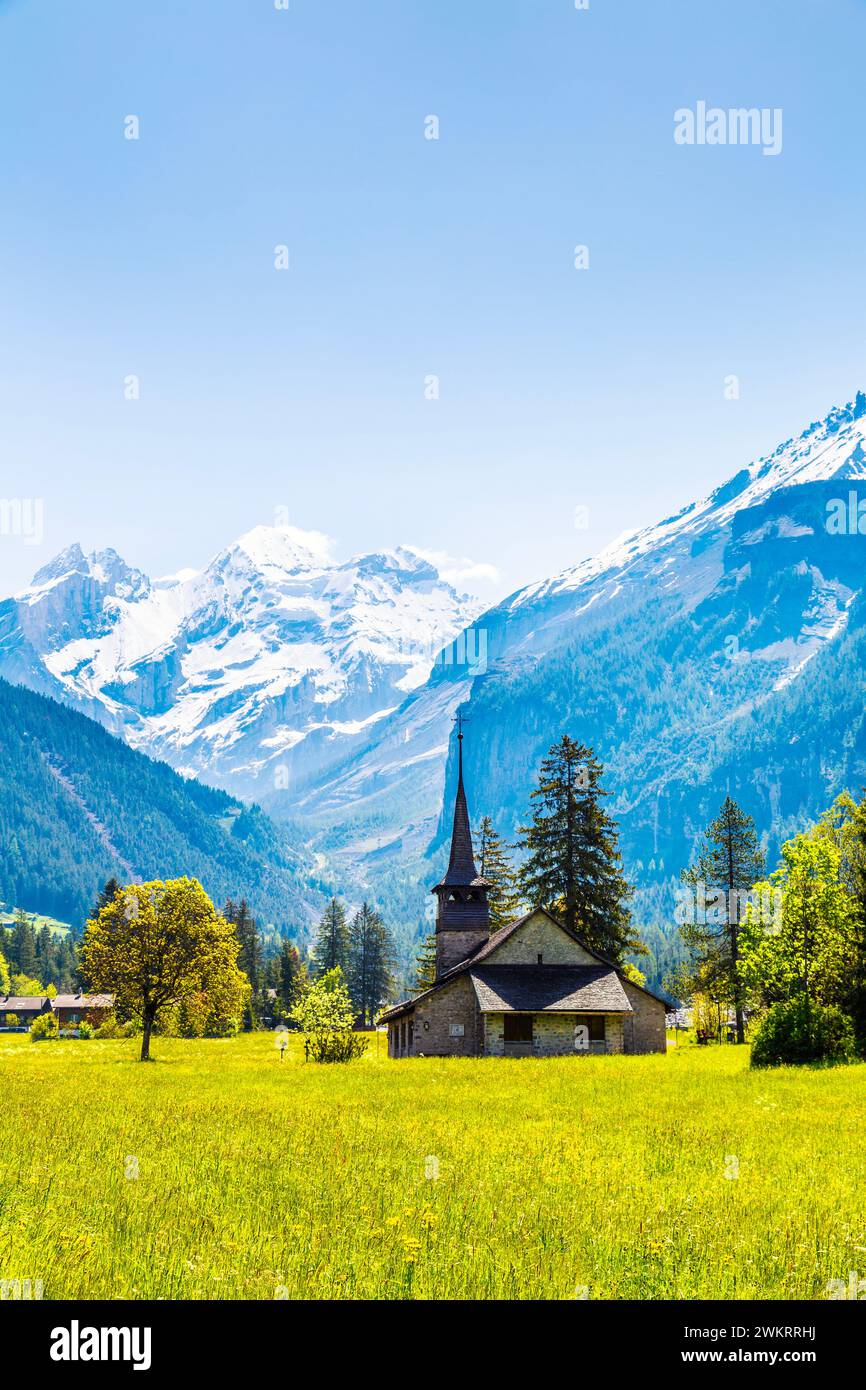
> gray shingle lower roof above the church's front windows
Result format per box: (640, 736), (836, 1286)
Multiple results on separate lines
(470, 965), (632, 1013)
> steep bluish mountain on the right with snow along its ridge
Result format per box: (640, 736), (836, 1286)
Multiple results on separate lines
(284, 393), (866, 898)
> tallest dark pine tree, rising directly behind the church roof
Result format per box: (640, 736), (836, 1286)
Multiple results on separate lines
(518, 734), (644, 965)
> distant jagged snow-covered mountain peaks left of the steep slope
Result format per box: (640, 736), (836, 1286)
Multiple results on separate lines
(0, 527), (477, 796)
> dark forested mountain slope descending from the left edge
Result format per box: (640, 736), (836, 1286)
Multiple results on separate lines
(0, 681), (318, 933)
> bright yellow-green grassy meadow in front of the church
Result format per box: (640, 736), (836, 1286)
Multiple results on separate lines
(0, 1034), (866, 1298)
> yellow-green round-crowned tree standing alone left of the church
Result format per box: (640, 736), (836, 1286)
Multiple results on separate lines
(81, 878), (249, 1062)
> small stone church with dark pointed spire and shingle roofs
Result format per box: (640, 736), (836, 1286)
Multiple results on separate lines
(381, 730), (667, 1058)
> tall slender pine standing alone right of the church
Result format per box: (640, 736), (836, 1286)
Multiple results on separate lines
(680, 796), (763, 1043)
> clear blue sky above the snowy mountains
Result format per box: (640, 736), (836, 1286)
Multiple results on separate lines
(0, 0), (866, 596)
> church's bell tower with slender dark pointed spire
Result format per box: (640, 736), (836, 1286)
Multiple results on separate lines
(431, 714), (491, 980)
